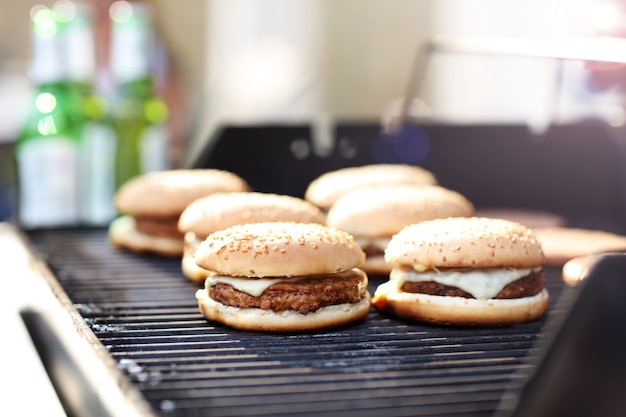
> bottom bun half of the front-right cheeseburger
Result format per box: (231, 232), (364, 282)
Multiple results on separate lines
(377, 283), (550, 326)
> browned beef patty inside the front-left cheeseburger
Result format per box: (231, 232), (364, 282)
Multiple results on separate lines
(209, 273), (367, 314)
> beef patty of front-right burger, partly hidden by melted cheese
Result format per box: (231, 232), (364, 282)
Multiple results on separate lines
(402, 271), (544, 299)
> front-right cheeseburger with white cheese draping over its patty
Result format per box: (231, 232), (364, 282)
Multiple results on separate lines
(373, 217), (549, 326)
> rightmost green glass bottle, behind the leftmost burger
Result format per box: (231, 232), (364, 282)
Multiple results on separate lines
(110, 1), (168, 188)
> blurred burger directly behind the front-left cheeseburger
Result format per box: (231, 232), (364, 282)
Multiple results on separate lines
(178, 192), (326, 282)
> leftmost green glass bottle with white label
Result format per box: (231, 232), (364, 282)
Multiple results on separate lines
(15, 7), (81, 228)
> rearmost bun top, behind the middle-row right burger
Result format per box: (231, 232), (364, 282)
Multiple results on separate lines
(304, 164), (437, 210)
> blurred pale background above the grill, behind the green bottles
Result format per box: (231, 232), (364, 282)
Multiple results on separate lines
(0, 0), (626, 223)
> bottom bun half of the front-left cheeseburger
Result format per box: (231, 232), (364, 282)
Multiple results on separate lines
(196, 289), (370, 332)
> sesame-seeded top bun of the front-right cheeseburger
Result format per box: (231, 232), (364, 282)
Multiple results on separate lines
(385, 217), (544, 270)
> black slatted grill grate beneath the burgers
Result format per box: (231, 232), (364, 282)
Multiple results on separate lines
(29, 229), (563, 417)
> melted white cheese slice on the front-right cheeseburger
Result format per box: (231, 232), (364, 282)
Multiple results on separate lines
(389, 268), (540, 300)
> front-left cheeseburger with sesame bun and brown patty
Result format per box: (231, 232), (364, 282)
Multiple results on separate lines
(194, 222), (370, 332)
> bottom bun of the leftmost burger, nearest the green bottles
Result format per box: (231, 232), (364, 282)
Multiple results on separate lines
(109, 215), (183, 257)
